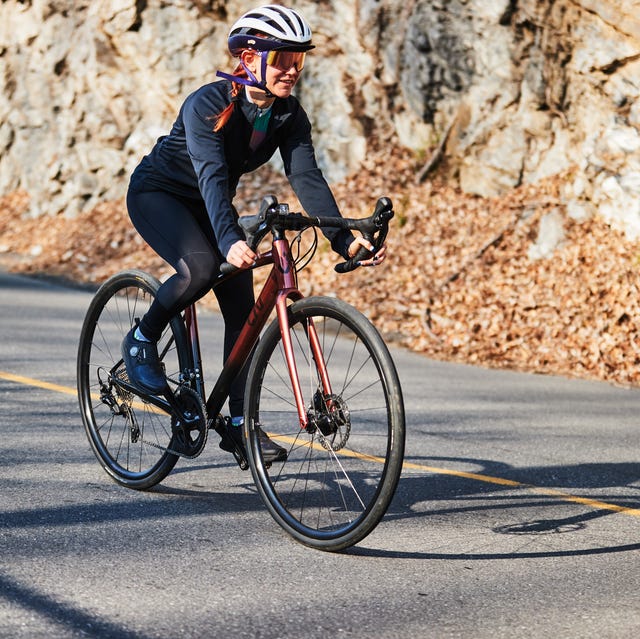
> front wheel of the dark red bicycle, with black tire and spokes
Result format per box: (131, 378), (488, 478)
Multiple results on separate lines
(245, 297), (405, 552)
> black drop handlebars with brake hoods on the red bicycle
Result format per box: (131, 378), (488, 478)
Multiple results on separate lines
(220, 195), (394, 277)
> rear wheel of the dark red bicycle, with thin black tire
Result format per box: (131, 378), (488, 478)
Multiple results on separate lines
(77, 270), (190, 490)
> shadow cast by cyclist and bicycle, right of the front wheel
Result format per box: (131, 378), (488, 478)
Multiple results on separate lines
(347, 457), (640, 560)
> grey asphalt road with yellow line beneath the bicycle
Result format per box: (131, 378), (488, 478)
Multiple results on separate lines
(0, 274), (640, 639)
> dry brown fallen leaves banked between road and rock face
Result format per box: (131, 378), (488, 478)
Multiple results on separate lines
(0, 151), (640, 385)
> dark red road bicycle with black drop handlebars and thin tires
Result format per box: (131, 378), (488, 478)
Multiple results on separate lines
(77, 196), (405, 551)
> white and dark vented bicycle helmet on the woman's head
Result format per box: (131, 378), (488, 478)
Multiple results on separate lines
(228, 4), (313, 56)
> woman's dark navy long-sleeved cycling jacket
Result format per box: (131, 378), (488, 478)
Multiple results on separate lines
(131, 80), (353, 257)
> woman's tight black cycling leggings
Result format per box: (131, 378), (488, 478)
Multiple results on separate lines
(127, 190), (254, 416)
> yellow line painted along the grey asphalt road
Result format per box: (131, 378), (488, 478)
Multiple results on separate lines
(0, 371), (640, 517)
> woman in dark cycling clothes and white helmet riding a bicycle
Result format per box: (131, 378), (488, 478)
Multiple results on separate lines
(122, 5), (385, 461)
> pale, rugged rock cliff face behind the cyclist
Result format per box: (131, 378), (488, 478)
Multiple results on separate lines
(0, 0), (640, 242)
